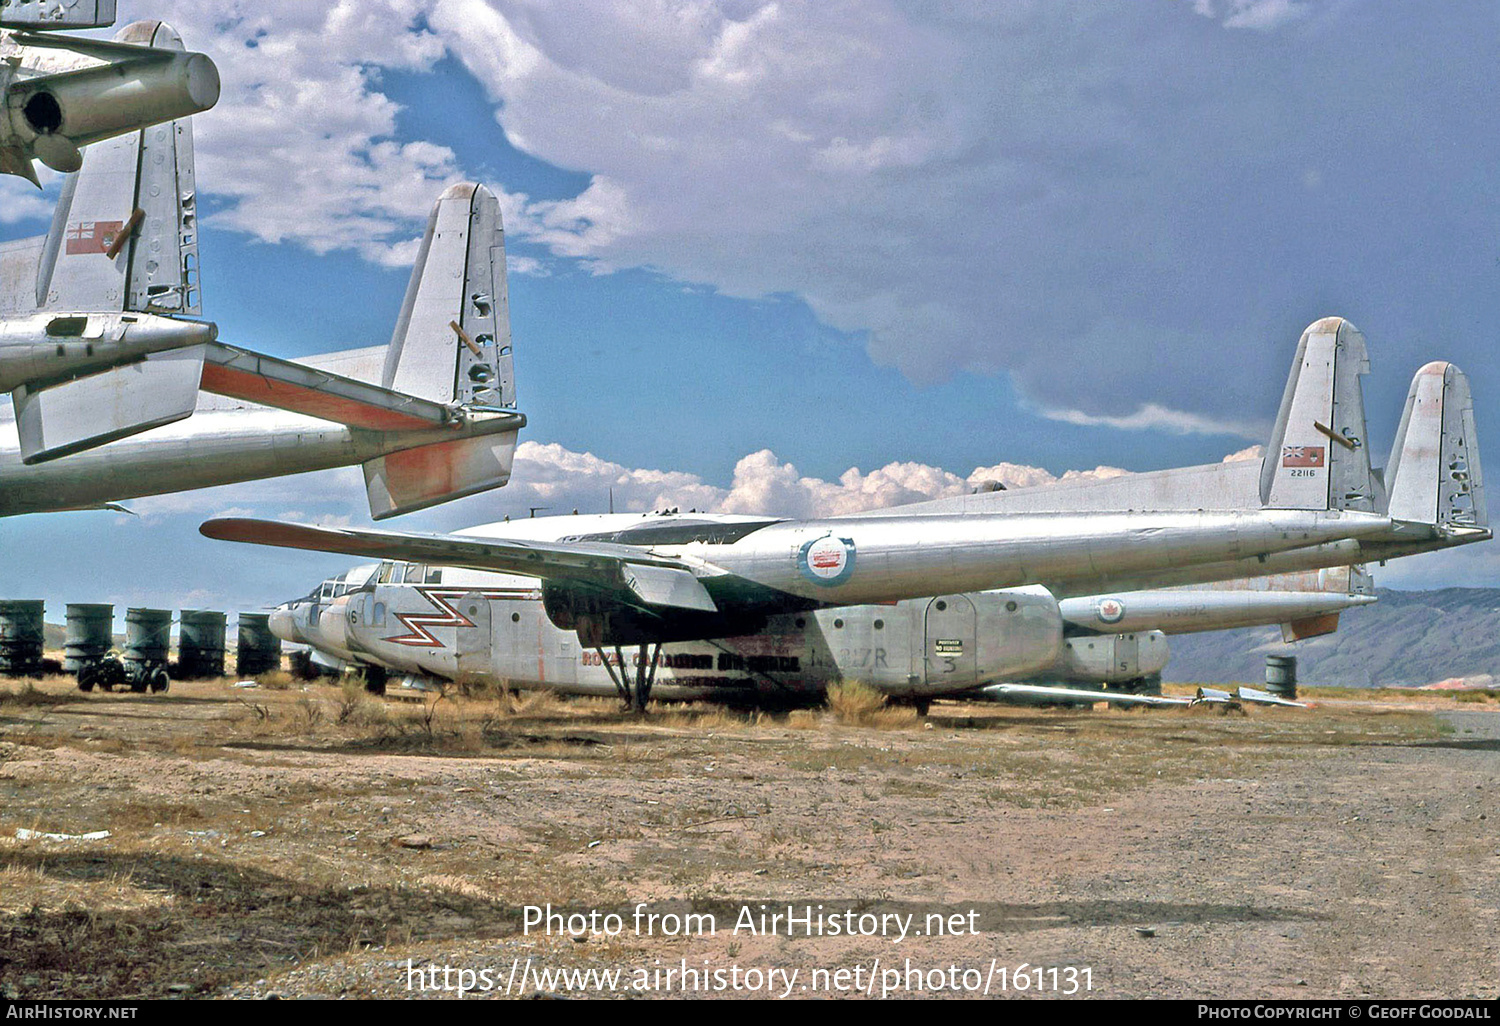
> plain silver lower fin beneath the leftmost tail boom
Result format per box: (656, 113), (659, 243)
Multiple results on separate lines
(12, 347), (203, 464)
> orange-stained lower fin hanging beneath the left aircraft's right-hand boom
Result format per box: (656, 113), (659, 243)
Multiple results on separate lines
(365, 431), (516, 521)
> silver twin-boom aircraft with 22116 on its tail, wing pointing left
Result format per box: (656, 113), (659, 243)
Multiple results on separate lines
(201, 318), (1490, 708)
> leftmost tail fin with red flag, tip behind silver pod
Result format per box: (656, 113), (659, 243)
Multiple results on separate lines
(36, 21), (203, 317)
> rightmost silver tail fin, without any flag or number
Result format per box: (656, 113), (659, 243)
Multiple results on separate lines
(1386, 362), (1490, 530)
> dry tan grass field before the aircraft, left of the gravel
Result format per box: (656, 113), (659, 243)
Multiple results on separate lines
(0, 669), (1490, 996)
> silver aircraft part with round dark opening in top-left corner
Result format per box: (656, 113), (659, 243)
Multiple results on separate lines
(0, 8), (219, 185)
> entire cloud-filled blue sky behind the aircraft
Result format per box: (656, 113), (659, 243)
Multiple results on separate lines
(0, 0), (1500, 621)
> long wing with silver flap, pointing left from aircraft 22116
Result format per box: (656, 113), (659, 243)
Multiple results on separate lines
(198, 518), (719, 612)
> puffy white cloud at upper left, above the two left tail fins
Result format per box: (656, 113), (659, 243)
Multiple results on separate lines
(150, 0), (462, 266)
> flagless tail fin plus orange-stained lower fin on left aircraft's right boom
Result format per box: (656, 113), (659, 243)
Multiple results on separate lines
(365, 185), (516, 521)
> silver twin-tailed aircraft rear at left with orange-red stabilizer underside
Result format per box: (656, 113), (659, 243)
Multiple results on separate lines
(0, 79), (525, 518)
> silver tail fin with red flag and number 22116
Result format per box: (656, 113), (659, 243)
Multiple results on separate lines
(1260, 317), (1379, 512)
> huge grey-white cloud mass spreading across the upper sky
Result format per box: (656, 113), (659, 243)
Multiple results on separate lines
(138, 0), (1500, 434)
